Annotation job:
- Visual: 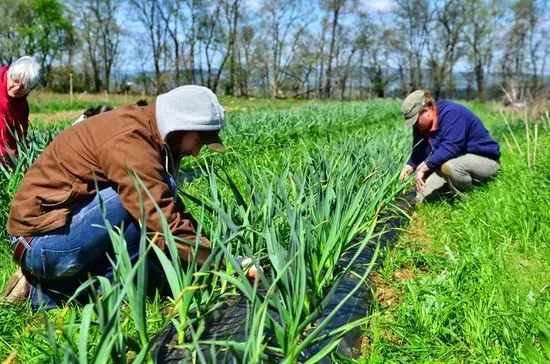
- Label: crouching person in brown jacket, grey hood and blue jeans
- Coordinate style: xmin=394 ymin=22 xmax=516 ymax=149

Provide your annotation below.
xmin=1 ymin=86 xmax=225 ymax=309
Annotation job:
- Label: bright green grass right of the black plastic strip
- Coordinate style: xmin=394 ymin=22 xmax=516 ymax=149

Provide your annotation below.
xmin=364 ymin=106 xmax=550 ymax=363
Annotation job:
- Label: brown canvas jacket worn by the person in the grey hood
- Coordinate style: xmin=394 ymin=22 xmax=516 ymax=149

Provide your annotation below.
xmin=7 ymin=105 xmax=210 ymax=264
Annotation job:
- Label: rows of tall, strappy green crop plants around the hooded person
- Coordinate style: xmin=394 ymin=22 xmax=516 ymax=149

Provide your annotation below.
xmin=0 ymin=102 xmax=409 ymax=363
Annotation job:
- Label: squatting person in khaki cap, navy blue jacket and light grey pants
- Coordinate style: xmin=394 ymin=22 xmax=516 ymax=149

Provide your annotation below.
xmin=400 ymin=90 xmax=500 ymax=203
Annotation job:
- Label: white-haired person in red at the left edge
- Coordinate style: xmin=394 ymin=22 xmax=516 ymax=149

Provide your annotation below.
xmin=0 ymin=56 xmax=40 ymax=164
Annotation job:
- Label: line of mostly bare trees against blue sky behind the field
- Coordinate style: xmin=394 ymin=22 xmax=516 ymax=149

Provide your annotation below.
xmin=0 ymin=0 xmax=550 ymax=100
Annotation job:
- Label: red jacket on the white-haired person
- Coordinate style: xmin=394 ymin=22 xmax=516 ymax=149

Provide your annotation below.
xmin=0 ymin=66 xmax=29 ymax=163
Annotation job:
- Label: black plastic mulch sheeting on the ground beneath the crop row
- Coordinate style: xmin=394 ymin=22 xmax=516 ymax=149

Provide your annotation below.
xmin=154 ymin=193 xmax=414 ymax=363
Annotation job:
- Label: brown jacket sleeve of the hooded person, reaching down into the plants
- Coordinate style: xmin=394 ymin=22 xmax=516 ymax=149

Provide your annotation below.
xmin=98 ymin=129 xmax=210 ymax=265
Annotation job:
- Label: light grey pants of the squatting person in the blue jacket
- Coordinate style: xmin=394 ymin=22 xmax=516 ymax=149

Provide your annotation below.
xmin=416 ymin=154 xmax=500 ymax=203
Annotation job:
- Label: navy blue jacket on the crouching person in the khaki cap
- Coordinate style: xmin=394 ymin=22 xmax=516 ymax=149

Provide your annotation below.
xmin=407 ymin=100 xmax=500 ymax=169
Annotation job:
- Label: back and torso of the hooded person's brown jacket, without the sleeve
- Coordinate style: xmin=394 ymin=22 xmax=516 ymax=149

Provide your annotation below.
xmin=8 ymin=105 xmax=162 ymax=235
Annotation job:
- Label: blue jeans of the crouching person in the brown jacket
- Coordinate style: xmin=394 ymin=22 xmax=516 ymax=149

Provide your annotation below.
xmin=11 ymin=176 xmax=176 ymax=310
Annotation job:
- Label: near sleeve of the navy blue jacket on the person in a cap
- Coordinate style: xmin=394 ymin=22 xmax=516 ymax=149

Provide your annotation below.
xmin=426 ymin=111 xmax=467 ymax=169
